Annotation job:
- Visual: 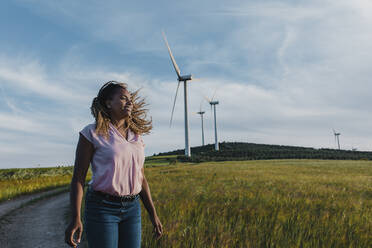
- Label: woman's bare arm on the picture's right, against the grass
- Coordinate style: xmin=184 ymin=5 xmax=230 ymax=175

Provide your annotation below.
xmin=140 ymin=168 xmax=163 ymax=238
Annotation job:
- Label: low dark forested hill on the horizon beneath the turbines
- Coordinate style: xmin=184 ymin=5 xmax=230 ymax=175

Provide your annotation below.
xmin=157 ymin=142 xmax=372 ymax=162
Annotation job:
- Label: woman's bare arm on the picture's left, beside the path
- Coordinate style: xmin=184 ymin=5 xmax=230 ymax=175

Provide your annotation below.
xmin=65 ymin=134 xmax=94 ymax=247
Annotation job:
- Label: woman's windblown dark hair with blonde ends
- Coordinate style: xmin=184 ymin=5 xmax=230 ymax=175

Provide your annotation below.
xmin=90 ymin=81 xmax=152 ymax=139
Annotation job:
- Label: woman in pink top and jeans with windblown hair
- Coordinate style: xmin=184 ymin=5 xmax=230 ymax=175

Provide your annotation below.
xmin=65 ymin=81 xmax=163 ymax=248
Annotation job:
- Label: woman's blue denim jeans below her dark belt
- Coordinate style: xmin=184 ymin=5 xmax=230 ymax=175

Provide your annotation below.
xmin=84 ymin=187 xmax=141 ymax=248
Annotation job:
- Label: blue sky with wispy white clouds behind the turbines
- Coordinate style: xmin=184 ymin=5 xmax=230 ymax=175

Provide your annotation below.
xmin=0 ymin=0 xmax=372 ymax=168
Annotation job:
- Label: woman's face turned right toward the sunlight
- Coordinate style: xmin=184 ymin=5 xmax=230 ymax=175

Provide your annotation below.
xmin=106 ymin=88 xmax=133 ymax=119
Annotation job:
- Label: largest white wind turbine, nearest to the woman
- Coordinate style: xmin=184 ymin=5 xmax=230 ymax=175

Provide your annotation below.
xmin=162 ymin=32 xmax=192 ymax=157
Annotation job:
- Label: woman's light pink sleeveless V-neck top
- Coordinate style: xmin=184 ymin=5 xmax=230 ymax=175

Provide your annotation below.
xmin=80 ymin=123 xmax=145 ymax=196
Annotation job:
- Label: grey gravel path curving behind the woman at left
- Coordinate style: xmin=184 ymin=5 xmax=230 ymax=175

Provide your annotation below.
xmin=0 ymin=192 xmax=69 ymax=248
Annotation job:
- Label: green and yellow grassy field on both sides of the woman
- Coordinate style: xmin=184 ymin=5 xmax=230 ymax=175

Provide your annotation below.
xmin=0 ymin=159 xmax=372 ymax=248
